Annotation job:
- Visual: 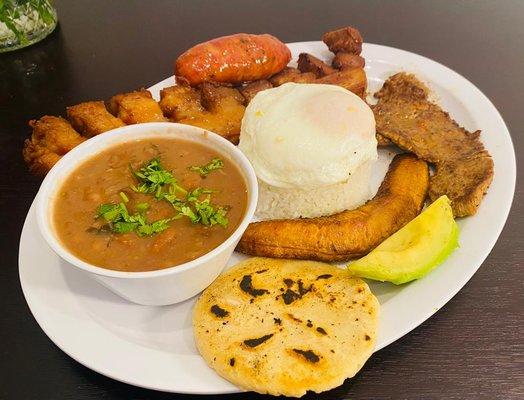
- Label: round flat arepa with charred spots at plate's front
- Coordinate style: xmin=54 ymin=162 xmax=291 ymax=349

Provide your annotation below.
xmin=193 ymin=258 xmax=379 ymax=397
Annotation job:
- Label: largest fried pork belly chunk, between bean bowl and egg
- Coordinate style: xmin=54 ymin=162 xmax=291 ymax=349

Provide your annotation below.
xmin=160 ymin=82 xmax=245 ymax=144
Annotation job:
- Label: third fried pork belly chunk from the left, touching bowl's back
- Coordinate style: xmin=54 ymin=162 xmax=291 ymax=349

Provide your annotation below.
xmin=107 ymin=89 xmax=166 ymax=125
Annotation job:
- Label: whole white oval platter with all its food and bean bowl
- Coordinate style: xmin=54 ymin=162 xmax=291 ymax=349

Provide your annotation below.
xmin=20 ymin=27 xmax=515 ymax=397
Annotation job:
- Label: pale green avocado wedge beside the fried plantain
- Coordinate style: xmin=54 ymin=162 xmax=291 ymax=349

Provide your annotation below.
xmin=348 ymin=196 xmax=459 ymax=285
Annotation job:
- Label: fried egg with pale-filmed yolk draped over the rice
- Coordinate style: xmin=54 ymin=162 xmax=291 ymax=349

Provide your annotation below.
xmin=239 ymin=83 xmax=377 ymax=188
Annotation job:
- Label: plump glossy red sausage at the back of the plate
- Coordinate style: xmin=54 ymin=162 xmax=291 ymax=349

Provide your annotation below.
xmin=175 ymin=33 xmax=291 ymax=86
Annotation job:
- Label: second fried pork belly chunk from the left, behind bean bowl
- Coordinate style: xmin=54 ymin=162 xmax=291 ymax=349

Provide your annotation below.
xmin=67 ymin=101 xmax=125 ymax=138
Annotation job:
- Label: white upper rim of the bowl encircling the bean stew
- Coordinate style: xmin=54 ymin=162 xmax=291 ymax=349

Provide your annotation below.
xmin=36 ymin=122 xmax=258 ymax=279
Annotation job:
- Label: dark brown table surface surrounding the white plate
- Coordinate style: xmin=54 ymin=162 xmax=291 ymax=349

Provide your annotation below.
xmin=0 ymin=0 xmax=524 ymax=400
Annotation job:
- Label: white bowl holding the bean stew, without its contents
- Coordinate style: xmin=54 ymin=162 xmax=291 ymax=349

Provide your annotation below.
xmin=36 ymin=122 xmax=258 ymax=305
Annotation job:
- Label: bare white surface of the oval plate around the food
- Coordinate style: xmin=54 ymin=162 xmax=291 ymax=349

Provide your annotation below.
xmin=19 ymin=42 xmax=516 ymax=394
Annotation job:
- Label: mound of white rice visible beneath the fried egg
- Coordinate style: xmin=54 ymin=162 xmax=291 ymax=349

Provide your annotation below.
xmin=255 ymin=160 xmax=375 ymax=220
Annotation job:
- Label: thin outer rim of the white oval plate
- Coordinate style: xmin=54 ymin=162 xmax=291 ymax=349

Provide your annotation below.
xmin=18 ymin=41 xmax=516 ymax=394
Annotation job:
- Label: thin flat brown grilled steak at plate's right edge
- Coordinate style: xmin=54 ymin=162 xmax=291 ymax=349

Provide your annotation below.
xmin=374 ymin=73 xmax=494 ymax=217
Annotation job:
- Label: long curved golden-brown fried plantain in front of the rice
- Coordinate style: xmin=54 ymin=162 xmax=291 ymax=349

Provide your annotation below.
xmin=237 ymin=154 xmax=429 ymax=262
